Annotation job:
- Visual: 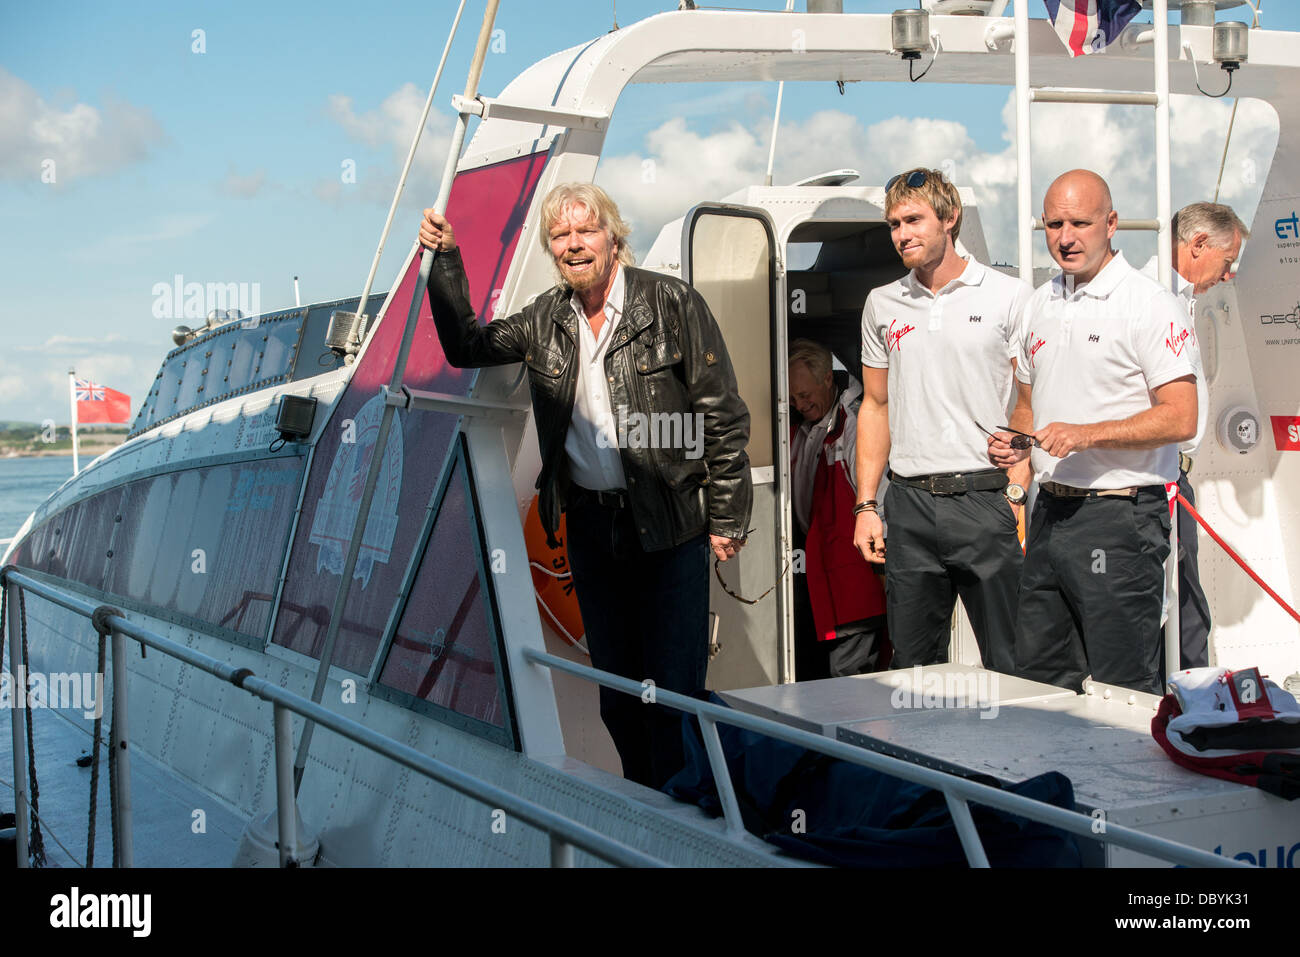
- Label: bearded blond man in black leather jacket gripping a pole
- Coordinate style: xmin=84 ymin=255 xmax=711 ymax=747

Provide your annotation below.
xmin=420 ymin=183 xmax=753 ymax=788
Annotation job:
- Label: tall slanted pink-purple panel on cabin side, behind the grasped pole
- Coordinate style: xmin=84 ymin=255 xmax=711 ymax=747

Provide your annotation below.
xmin=273 ymin=153 xmax=546 ymax=674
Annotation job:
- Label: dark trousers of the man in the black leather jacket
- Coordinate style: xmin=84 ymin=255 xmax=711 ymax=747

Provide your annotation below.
xmin=566 ymin=501 xmax=709 ymax=788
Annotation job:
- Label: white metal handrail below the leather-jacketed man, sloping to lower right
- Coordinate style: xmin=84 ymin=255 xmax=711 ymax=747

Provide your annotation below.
xmin=523 ymin=648 xmax=1249 ymax=867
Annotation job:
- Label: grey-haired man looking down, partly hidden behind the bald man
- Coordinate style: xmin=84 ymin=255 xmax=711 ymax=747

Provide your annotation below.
xmin=1141 ymin=203 xmax=1251 ymax=672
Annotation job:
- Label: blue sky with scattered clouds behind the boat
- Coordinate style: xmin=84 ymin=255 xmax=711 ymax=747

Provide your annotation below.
xmin=0 ymin=0 xmax=1300 ymax=423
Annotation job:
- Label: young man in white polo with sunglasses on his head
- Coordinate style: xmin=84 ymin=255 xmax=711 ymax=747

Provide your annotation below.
xmin=854 ymin=169 xmax=1032 ymax=672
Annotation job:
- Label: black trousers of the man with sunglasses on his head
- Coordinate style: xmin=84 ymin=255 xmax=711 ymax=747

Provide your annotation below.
xmin=884 ymin=482 xmax=1024 ymax=674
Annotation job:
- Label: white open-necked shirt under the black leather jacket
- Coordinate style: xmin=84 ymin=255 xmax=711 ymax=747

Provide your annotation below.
xmin=564 ymin=265 xmax=628 ymax=492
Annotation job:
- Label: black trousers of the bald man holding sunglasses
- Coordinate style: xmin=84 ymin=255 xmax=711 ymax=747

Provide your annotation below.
xmin=1015 ymin=486 xmax=1169 ymax=694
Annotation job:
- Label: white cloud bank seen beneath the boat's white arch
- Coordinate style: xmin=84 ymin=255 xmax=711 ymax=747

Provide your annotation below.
xmin=597 ymin=95 xmax=1277 ymax=265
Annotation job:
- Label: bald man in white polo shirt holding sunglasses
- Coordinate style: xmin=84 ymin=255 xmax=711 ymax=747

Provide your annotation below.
xmin=989 ymin=170 xmax=1196 ymax=694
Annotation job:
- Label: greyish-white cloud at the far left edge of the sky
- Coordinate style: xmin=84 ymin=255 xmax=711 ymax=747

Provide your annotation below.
xmin=0 ymin=68 xmax=164 ymax=185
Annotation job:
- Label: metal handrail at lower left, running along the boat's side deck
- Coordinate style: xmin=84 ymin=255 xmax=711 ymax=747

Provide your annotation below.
xmin=0 ymin=566 xmax=666 ymax=867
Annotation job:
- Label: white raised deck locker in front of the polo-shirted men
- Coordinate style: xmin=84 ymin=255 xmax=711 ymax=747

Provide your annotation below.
xmin=723 ymin=664 xmax=1300 ymax=866
